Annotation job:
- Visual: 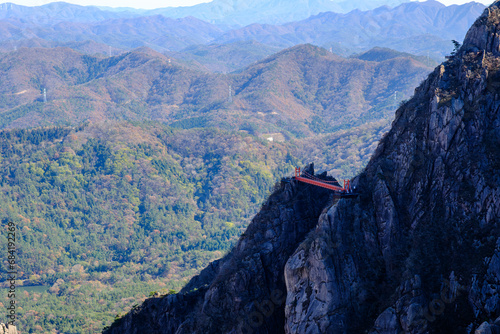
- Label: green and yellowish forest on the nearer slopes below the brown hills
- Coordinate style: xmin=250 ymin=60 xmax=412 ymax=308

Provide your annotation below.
xmin=0 ymin=121 xmax=386 ymax=333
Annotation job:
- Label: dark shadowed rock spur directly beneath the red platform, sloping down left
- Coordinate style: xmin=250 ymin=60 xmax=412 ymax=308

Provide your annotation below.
xmin=104 ymin=166 xmax=332 ymax=334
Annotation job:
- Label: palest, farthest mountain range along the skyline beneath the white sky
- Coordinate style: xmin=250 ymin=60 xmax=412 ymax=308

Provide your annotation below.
xmin=0 ymin=0 xmax=405 ymax=26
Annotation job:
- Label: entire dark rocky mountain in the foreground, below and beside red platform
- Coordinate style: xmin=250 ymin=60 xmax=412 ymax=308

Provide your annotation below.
xmin=105 ymin=2 xmax=500 ymax=334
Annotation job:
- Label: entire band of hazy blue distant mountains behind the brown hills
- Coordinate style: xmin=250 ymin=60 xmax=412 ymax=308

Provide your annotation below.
xmin=0 ymin=0 xmax=484 ymax=58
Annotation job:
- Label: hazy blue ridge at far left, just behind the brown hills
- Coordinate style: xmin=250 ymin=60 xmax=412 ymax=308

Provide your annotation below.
xmin=0 ymin=15 xmax=223 ymax=51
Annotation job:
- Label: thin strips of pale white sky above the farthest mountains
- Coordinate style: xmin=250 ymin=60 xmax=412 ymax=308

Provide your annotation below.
xmin=0 ymin=0 xmax=493 ymax=9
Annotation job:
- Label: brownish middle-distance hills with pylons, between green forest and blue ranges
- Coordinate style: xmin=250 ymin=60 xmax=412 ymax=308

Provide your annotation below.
xmin=0 ymin=45 xmax=431 ymax=139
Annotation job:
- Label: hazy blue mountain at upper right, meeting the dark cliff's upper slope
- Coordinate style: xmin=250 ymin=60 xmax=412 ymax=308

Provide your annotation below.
xmin=217 ymin=1 xmax=484 ymax=58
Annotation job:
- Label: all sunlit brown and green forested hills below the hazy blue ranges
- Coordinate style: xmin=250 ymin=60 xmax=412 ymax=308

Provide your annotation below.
xmin=0 ymin=45 xmax=431 ymax=333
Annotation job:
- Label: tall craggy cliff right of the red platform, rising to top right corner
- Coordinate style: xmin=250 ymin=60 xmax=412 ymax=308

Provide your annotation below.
xmin=285 ymin=2 xmax=500 ymax=334
